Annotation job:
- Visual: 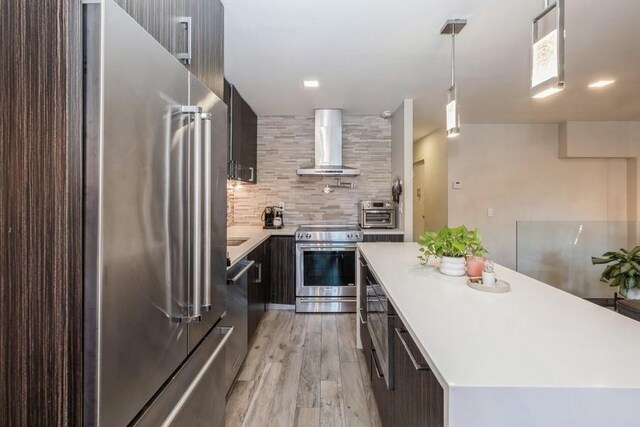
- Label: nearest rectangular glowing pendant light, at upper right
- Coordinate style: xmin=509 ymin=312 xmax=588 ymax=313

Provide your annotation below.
xmin=531 ymin=0 xmax=564 ymax=98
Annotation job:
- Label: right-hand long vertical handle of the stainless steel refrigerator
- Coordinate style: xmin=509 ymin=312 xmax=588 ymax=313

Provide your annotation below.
xmin=201 ymin=113 xmax=213 ymax=312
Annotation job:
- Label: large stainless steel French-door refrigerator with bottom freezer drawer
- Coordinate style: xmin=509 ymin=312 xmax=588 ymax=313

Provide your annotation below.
xmin=84 ymin=0 xmax=233 ymax=427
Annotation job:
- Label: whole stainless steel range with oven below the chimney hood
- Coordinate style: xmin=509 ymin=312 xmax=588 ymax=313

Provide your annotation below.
xmin=296 ymin=225 xmax=363 ymax=313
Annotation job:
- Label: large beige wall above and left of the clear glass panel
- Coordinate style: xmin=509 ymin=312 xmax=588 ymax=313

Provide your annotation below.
xmin=447 ymin=124 xmax=627 ymax=268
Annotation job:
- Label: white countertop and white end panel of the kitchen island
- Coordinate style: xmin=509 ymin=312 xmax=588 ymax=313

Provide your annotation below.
xmin=358 ymin=243 xmax=640 ymax=427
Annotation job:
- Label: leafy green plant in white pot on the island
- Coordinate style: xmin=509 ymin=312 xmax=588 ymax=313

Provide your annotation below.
xmin=418 ymin=225 xmax=487 ymax=276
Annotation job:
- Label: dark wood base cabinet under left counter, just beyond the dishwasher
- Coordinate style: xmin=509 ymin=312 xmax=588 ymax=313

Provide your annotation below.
xmin=247 ymin=240 xmax=271 ymax=342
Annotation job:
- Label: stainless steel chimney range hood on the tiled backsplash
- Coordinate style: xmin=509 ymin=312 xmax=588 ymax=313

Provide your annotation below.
xmin=296 ymin=109 xmax=360 ymax=176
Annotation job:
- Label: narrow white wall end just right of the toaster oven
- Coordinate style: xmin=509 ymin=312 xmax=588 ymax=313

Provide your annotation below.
xmin=391 ymin=99 xmax=413 ymax=242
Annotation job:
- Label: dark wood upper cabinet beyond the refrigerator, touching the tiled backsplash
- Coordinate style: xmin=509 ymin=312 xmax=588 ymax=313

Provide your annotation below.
xmin=226 ymin=85 xmax=258 ymax=183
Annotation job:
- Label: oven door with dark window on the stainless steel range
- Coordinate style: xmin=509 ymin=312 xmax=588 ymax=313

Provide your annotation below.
xmin=296 ymin=243 xmax=357 ymax=301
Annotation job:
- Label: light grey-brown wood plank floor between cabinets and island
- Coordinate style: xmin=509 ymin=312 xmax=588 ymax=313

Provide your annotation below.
xmin=226 ymin=311 xmax=381 ymax=427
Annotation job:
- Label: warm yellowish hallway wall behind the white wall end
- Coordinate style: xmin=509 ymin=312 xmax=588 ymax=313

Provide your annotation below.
xmin=413 ymin=130 xmax=450 ymax=231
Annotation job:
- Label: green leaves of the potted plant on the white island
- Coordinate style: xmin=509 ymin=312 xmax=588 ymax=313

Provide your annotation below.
xmin=418 ymin=225 xmax=487 ymax=264
